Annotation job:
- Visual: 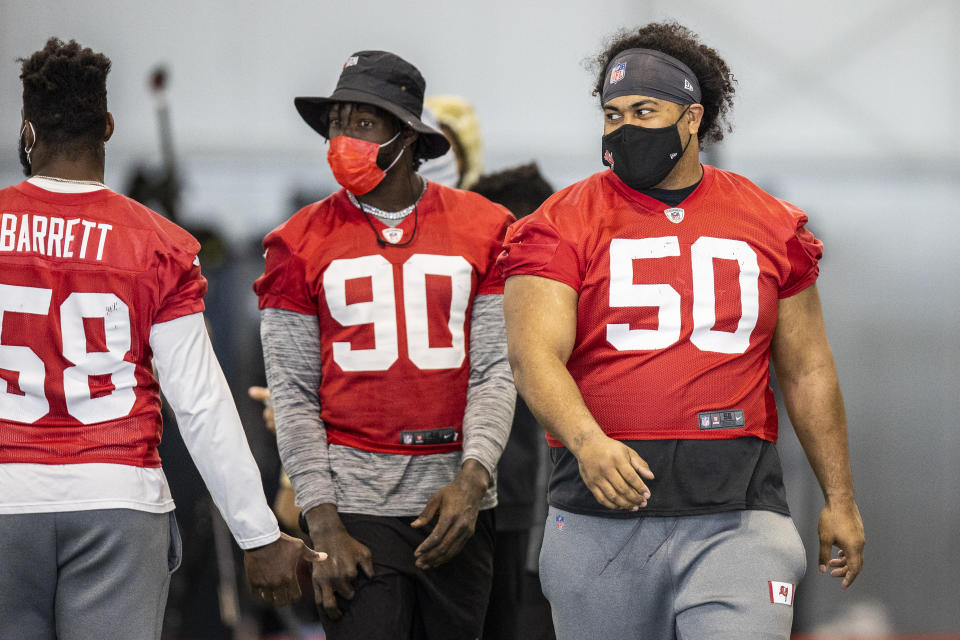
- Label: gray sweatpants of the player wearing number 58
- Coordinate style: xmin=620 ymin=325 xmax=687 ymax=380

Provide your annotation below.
xmin=0 ymin=509 xmax=180 ymax=640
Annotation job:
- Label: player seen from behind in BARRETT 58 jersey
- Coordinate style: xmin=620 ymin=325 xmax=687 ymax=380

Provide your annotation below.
xmin=0 ymin=38 xmax=323 ymax=640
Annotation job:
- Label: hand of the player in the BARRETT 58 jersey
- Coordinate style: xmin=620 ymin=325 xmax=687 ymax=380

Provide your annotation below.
xmin=243 ymin=533 xmax=327 ymax=606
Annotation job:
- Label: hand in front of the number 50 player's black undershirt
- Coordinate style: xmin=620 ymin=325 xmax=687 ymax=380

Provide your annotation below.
xmin=572 ymin=432 xmax=653 ymax=510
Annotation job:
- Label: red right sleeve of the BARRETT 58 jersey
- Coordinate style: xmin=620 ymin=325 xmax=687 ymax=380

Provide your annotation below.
xmin=153 ymin=244 xmax=207 ymax=324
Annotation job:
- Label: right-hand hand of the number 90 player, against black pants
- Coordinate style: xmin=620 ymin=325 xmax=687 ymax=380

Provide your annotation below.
xmin=410 ymin=460 xmax=490 ymax=569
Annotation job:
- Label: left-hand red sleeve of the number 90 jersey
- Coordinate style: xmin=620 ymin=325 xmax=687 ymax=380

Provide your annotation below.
xmin=253 ymin=231 xmax=317 ymax=316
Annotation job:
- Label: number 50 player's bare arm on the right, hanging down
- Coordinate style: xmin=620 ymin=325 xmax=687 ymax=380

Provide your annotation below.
xmin=771 ymin=285 xmax=864 ymax=588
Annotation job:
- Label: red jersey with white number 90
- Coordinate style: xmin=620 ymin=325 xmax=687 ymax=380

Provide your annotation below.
xmin=254 ymin=182 xmax=513 ymax=454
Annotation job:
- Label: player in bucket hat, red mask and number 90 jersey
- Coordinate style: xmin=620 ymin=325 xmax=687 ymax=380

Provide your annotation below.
xmin=254 ymin=51 xmax=516 ymax=640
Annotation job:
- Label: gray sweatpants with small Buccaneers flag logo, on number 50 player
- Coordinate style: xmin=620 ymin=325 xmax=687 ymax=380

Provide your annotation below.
xmin=540 ymin=507 xmax=806 ymax=640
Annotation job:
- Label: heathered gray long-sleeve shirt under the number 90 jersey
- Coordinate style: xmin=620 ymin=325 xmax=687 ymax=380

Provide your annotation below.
xmin=260 ymin=295 xmax=516 ymax=516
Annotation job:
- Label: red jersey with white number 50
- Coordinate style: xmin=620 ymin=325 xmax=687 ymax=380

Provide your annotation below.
xmin=499 ymin=166 xmax=822 ymax=446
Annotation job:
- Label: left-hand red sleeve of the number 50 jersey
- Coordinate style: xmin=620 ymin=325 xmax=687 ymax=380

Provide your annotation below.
xmin=497 ymin=214 xmax=583 ymax=291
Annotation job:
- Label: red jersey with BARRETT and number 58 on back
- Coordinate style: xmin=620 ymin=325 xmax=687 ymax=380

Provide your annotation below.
xmin=0 ymin=182 xmax=207 ymax=467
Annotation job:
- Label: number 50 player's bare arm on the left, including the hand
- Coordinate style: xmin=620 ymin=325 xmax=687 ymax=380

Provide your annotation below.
xmin=504 ymin=276 xmax=653 ymax=510
